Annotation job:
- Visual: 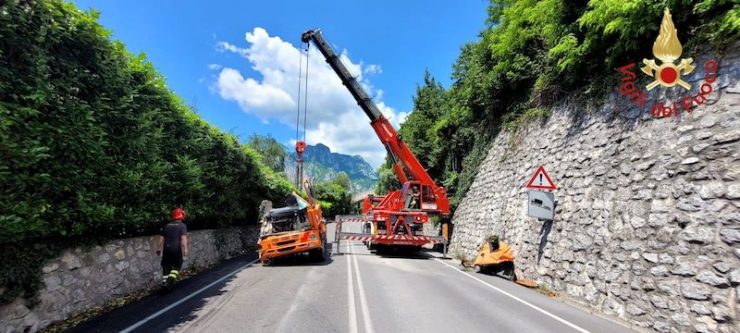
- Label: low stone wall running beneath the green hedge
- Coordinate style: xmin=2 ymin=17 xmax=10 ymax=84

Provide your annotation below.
xmin=0 ymin=225 xmax=259 ymax=332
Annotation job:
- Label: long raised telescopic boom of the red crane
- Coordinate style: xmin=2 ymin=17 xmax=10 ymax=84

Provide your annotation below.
xmin=301 ymin=29 xmax=450 ymax=216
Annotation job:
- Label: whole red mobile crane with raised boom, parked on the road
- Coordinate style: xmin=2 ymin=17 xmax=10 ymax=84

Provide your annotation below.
xmin=301 ymin=29 xmax=450 ymax=247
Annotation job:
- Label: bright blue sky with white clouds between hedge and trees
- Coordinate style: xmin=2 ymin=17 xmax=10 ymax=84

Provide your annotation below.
xmin=75 ymin=0 xmax=487 ymax=166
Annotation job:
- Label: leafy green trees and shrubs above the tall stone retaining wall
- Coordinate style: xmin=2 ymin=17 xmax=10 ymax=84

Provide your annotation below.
xmin=376 ymin=0 xmax=740 ymax=208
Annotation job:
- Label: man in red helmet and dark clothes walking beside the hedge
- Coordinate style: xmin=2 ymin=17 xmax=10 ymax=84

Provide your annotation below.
xmin=157 ymin=207 xmax=189 ymax=284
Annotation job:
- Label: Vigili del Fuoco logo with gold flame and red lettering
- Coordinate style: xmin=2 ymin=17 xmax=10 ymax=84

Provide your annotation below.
xmin=619 ymin=8 xmax=719 ymax=118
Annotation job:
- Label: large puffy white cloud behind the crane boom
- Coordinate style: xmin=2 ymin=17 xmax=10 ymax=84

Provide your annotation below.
xmin=214 ymin=27 xmax=407 ymax=167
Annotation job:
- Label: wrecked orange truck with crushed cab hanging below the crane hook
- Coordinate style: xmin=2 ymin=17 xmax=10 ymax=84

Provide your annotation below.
xmin=257 ymin=186 xmax=326 ymax=265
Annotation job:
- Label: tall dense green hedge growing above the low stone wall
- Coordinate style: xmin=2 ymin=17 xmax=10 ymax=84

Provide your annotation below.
xmin=0 ymin=0 xmax=291 ymax=301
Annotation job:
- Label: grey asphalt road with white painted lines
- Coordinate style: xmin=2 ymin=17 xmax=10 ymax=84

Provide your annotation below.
xmin=70 ymin=220 xmax=631 ymax=333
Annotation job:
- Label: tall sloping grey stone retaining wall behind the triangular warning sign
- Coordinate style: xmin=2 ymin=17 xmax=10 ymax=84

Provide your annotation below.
xmin=450 ymin=45 xmax=740 ymax=332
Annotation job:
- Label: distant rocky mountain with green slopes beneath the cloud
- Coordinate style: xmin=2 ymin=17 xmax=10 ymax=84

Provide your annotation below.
xmin=285 ymin=143 xmax=378 ymax=192
